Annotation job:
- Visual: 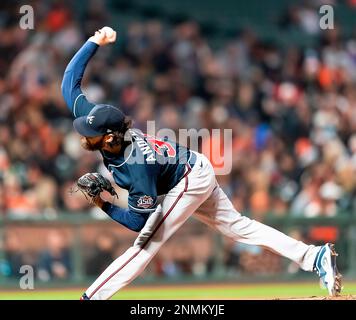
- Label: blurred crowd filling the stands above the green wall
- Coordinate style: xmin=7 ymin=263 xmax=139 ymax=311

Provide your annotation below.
xmin=0 ymin=1 xmax=356 ymax=278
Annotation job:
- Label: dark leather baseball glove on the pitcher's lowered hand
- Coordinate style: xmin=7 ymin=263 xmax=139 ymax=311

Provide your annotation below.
xmin=77 ymin=172 xmax=118 ymax=202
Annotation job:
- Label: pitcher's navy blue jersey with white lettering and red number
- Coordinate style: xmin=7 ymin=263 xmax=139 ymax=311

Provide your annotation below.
xmin=101 ymin=129 xmax=192 ymax=212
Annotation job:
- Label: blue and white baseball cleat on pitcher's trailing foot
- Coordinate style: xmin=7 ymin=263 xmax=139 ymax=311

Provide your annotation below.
xmin=314 ymin=243 xmax=342 ymax=296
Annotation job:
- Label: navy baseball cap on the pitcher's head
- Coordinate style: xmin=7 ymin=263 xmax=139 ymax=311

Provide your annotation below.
xmin=73 ymin=104 xmax=125 ymax=137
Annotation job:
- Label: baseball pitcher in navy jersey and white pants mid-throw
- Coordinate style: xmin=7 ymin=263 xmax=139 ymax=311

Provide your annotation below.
xmin=62 ymin=27 xmax=341 ymax=300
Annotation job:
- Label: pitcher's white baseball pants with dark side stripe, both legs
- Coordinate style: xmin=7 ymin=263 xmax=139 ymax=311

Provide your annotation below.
xmin=86 ymin=153 xmax=320 ymax=300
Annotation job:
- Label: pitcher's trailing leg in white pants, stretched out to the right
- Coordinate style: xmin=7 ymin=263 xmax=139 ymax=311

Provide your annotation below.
xmin=196 ymin=187 xmax=320 ymax=271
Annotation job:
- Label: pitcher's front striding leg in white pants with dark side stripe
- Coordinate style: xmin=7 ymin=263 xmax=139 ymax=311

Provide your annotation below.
xmin=86 ymin=160 xmax=214 ymax=300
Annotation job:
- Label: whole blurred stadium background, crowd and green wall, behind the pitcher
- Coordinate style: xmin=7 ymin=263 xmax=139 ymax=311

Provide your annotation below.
xmin=0 ymin=0 xmax=356 ymax=297
